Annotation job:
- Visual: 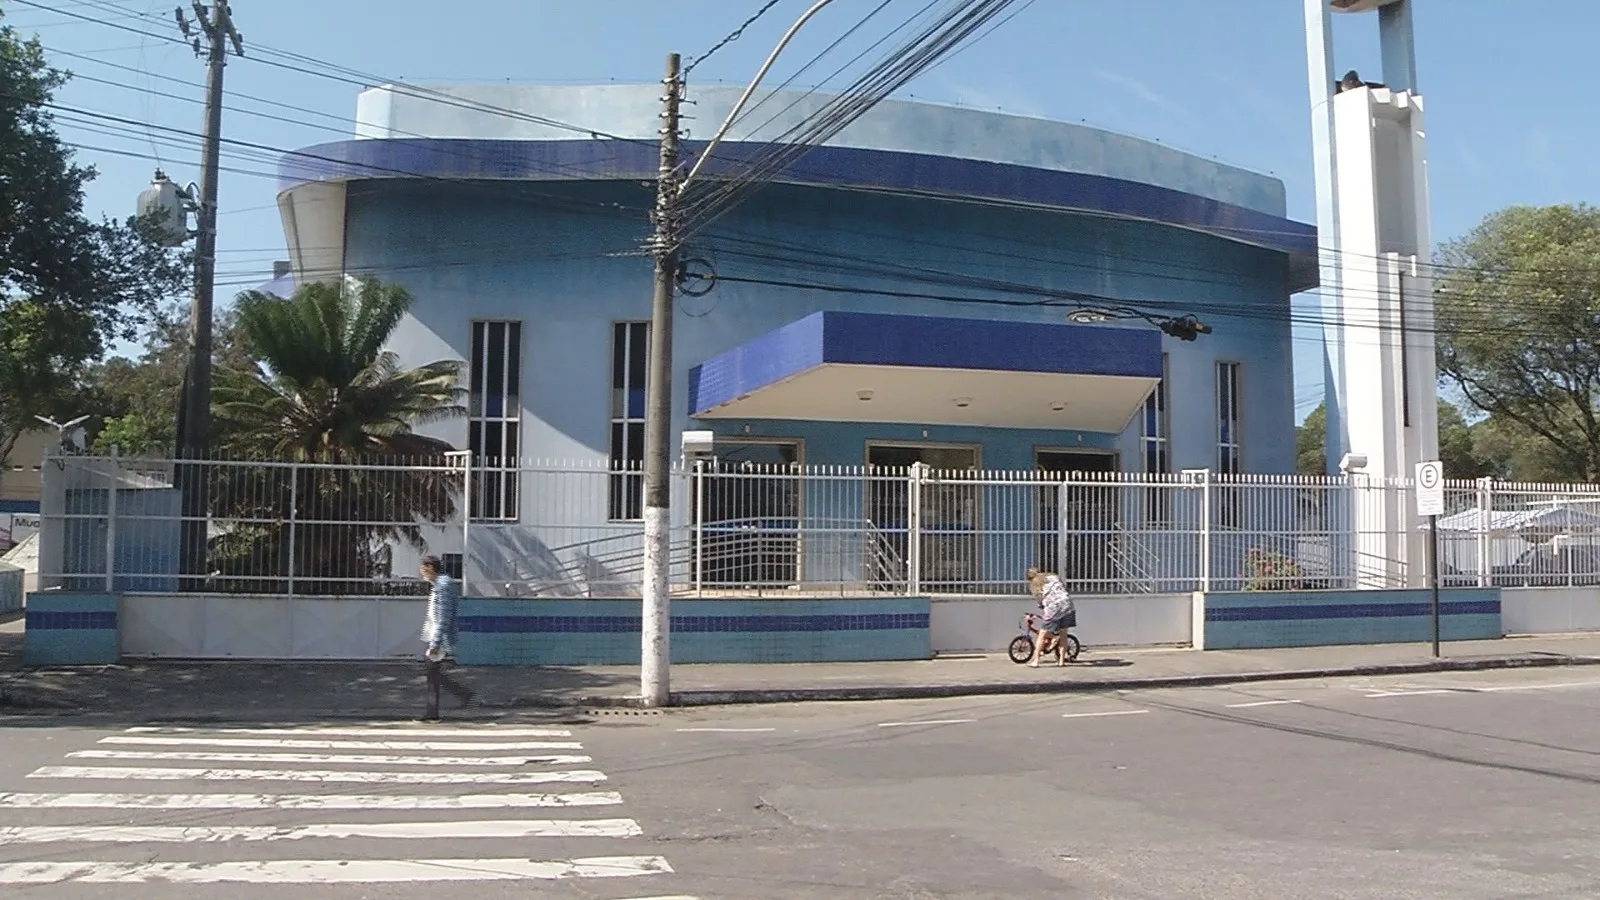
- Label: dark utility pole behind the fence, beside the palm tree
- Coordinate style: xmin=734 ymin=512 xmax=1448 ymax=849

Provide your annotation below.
xmin=176 ymin=0 xmax=245 ymax=586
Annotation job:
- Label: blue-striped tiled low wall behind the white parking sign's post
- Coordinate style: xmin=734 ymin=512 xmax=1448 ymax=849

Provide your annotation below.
xmin=1194 ymin=588 xmax=1504 ymax=650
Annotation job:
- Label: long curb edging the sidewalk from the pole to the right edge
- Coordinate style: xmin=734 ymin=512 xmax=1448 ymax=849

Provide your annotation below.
xmin=537 ymin=655 xmax=1600 ymax=709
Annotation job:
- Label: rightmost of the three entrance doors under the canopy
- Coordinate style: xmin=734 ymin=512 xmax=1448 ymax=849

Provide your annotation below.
xmin=1034 ymin=450 xmax=1122 ymax=594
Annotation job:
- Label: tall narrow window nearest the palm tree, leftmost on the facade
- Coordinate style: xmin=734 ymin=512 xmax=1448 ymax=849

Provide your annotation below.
xmin=467 ymin=322 xmax=522 ymax=520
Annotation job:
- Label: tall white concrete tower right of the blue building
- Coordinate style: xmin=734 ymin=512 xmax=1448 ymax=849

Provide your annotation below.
xmin=1304 ymin=0 xmax=1448 ymax=588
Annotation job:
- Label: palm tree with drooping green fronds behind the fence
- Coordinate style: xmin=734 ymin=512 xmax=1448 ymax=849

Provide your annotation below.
xmin=211 ymin=279 xmax=466 ymax=594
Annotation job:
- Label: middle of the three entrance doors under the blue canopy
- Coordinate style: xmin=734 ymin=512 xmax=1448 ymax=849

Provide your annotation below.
xmin=867 ymin=444 xmax=979 ymax=594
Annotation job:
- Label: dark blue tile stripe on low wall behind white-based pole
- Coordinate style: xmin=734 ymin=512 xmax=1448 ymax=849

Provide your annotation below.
xmin=458 ymin=613 xmax=928 ymax=634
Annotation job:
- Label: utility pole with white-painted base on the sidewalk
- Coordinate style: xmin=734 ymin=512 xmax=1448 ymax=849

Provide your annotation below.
xmin=638 ymin=53 xmax=683 ymax=706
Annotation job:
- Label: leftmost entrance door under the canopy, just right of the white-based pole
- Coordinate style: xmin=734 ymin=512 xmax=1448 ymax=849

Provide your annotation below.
xmin=694 ymin=440 xmax=800 ymax=588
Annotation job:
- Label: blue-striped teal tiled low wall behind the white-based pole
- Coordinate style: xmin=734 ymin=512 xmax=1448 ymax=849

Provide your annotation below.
xmin=456 ymin=597 xmax=933 ymax=666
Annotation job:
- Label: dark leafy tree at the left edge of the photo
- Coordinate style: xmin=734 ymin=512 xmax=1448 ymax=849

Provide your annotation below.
xmin=0 ymin=17 xmax=189 ymax=474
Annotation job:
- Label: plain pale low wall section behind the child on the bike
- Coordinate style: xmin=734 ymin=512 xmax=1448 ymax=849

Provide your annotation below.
xmin=930 ymin=594 xmax=1194 ymax=653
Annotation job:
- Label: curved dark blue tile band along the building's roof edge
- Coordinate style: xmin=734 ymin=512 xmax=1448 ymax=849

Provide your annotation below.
xmin=278 ymin=138 xmax=1317 ymax=275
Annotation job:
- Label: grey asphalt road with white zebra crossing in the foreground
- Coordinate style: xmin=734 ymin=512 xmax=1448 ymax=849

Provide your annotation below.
xmin=0 ymin=668 xmax=1600 ymax=900
